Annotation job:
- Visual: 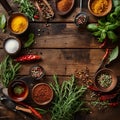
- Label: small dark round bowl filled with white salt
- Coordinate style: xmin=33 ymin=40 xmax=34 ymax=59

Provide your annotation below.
xmin=3 ymin=37 xmax=21 ymax=55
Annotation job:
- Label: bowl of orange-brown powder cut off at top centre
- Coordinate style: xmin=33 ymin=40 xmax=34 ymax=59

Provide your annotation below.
xmin=56 ymin=0 xmax=75 ymax=15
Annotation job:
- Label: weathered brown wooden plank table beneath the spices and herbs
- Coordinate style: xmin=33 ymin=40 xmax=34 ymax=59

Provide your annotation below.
xmin=0 ymin=0 xmax=120 ymax=120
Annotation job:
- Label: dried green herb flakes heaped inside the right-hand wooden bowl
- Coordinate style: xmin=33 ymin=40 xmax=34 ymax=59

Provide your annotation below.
xmin=97 ymin=74 xmax=112 ymax=88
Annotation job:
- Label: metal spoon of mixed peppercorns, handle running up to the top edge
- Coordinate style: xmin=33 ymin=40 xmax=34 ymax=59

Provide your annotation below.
xmin=74 ymin=0 xmax=88 ymax=27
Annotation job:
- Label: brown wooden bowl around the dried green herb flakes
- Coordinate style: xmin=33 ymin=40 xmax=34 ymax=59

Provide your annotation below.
xmin=94 ymin=68 xmax=117 ymax=92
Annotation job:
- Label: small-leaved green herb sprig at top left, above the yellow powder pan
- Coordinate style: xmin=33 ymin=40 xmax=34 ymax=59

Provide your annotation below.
xmin=14 ymin=0 xmax=35 ymax=21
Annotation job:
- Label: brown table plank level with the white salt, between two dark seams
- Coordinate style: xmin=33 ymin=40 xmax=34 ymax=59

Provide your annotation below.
xmin=0 ymin=23 xmax=99 ymax=48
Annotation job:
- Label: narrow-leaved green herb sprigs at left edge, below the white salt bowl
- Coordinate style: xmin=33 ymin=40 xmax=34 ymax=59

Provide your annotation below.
xmin=0 ymin=56 xmax=21 ymax=87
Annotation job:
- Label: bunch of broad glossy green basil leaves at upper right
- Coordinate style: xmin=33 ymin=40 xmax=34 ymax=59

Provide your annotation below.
xmin=87 ymin=5 xmax=120 ymax=42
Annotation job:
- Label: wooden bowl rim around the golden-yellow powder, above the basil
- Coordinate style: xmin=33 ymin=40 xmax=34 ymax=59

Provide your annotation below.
xmin=88 ymin=0 xmax=112 ymax=17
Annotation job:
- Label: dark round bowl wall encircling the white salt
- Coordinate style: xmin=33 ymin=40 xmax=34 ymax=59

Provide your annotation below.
xmin=3 ymin=36 xmax=22 ymax=56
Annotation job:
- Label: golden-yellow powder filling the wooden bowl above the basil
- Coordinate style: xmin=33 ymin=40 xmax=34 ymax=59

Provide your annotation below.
xmin=91 ymin=0 xmax=109 ymax=14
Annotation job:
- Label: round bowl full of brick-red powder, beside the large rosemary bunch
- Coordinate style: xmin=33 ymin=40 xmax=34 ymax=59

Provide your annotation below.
xmin=32 ymin=83 xmax=53 ymax=105
